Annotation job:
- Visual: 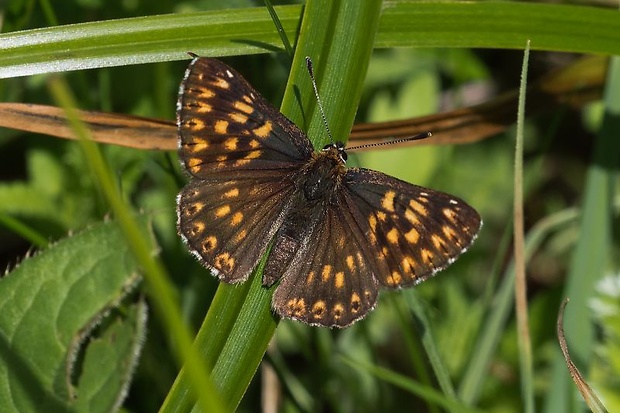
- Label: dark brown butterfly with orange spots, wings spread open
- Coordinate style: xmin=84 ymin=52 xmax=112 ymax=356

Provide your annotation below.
xmin=176 ymin=56 xmax=482 ymax=327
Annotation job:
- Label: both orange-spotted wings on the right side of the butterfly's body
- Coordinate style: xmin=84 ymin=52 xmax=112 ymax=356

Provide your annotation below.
xmin=272 ymin=168 xmax=481 ymax=327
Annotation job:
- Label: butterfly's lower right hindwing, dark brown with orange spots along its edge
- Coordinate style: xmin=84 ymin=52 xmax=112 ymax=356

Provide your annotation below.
xmin=272 ymin=205 xmax=378 ymax=327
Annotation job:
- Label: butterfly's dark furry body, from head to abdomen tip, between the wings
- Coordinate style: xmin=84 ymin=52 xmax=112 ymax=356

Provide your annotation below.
xmin=263 ymin=143 xmax=346 ymax=285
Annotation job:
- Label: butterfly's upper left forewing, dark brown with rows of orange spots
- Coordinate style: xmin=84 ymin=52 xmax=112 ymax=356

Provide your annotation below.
xmin=177 ymin=58 xmax=312 ymax=178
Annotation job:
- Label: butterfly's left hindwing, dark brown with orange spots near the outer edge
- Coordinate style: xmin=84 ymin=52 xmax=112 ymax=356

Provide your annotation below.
xmin=177 ymin=171 xmax=300 ymax=283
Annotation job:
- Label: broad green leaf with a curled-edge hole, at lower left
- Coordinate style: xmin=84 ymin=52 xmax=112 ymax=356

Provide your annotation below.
xmin=0 ymin=220 xmax=147 ymax=412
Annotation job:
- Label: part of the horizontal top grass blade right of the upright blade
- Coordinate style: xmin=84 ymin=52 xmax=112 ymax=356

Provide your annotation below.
xmin=376 ymin=1 xmax=620 ymax=54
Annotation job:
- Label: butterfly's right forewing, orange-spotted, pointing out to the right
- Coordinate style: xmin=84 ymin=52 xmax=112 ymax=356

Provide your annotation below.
xmin=341 ymin=168 xmax=482 ymax=288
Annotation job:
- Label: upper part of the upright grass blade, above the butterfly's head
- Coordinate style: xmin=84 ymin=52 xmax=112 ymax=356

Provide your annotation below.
xmin=282 ymin=0 xmax=381 ymax=148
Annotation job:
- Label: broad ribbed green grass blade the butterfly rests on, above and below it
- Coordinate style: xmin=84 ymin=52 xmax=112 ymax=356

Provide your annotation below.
xmin=207 ymin=0 xmax=381 ymax=408
